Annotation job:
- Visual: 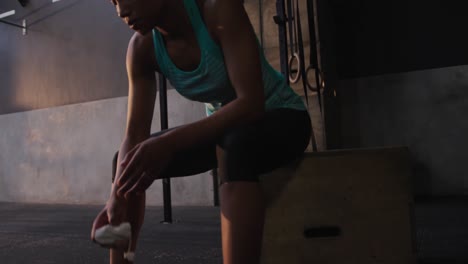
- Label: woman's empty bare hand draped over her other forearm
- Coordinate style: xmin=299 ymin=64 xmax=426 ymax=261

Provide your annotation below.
xmin=116 ymin=137 xmax=174 ymax=198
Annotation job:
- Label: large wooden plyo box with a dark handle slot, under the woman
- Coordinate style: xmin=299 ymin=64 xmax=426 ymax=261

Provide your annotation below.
xmin=260 ymin=147 xmax=416 ymax=264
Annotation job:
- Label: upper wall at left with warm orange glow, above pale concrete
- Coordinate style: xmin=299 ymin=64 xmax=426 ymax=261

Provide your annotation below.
xmin=0 ymin=0 xmax=132 ymax=114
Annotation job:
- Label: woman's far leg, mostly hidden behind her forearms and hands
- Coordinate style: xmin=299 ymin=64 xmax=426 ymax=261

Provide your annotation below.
xmin=106 ymin=127 xmax=217 ymax=264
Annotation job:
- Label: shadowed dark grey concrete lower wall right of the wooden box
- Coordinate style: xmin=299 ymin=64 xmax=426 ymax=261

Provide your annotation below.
xmin=337 ymin=66 xmax=468 ymax=195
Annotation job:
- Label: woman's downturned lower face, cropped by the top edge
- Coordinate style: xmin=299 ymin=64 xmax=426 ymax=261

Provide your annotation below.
xmin=111 ymin=0 xmax=163 ymax=35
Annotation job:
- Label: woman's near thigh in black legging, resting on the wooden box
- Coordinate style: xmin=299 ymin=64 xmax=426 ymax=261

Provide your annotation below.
xmin=218 ymin=108 xmax=311 ymax=182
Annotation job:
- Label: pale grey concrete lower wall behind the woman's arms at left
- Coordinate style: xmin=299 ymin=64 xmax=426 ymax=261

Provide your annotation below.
xmin=0 ymin=90 xmax=213 ymax=205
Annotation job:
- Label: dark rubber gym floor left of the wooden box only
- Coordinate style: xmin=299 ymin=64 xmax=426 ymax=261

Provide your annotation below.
xmin=0 ymin=203 xmax=222 ymax=264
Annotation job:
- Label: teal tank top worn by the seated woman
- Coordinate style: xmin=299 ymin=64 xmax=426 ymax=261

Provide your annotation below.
xmin=153 ymin=0 xmax=306 ymax=116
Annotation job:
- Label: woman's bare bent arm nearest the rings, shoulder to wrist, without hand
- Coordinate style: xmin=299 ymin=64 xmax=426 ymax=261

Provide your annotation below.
xmin=165 ymin=0 xmax=265 ymax=150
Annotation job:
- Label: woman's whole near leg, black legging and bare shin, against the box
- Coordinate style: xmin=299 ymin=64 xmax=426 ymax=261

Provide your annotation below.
xmin=217 ymin=109 xmax=311 ymax=264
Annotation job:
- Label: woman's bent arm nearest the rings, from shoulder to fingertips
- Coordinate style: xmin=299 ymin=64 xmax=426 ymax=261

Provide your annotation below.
xmin=119 ymin=0 xmax=265 ymax=193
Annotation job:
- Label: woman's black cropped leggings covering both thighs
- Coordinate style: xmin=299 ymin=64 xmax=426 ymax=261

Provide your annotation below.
xmin=151 ymin=108 xmax=311 ymax=182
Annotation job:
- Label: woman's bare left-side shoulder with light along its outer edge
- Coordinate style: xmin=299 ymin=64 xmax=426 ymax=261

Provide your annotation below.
xmin=127 ymin=32 xmax=159 ymax=76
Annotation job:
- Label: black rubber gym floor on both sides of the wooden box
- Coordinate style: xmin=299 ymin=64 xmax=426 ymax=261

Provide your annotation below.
xmin=0 ymin=199 xmax=468 ymax=264
